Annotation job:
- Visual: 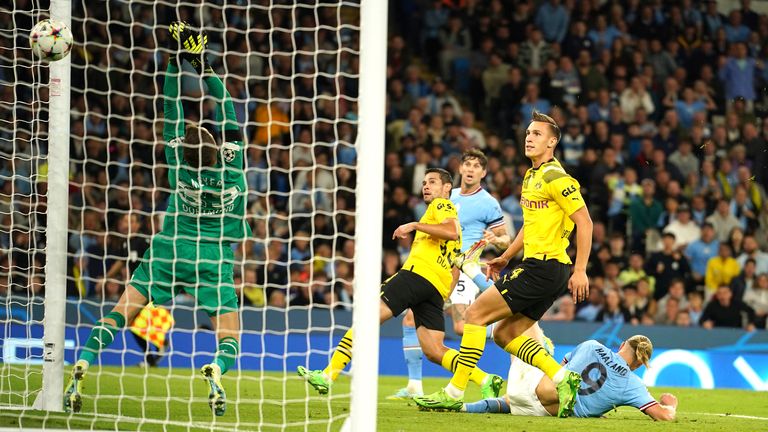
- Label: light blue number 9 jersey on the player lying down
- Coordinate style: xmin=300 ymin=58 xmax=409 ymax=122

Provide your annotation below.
xmin=565 ymin=340 xmax=658 ymax=417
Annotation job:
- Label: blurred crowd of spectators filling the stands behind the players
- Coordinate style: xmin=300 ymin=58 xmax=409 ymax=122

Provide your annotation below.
xmin=0 ymin=0 xmax=768 ymax=329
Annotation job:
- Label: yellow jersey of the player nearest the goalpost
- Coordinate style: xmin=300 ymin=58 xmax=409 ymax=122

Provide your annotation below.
xmin=403 ymin=198 xmax=461 ymax=299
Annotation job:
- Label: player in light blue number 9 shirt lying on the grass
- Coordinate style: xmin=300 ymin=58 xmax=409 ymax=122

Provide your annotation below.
xmin=459 ymin=335 xmax=677 ymax=420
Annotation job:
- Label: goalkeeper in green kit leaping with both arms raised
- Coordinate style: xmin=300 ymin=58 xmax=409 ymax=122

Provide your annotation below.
xmin=64 ymin=22 xmax=251 ymax=416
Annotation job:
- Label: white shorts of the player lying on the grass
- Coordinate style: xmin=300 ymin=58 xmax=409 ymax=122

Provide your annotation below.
xmin=506 ymin=357 xmax=550 ymax=417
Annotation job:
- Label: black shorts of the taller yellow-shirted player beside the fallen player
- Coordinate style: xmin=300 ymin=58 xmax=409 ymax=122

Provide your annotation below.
xmin=496 ymin=258 xmax=571 ymax=321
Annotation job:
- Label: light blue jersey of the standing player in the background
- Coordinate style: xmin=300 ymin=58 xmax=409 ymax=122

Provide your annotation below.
xmin=451 ymin=188 xmax=504 ymax=252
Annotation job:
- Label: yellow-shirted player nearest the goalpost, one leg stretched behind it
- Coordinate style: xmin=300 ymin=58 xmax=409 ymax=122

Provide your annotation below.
xmin=297 ymin=168 xmax=503 ymax=397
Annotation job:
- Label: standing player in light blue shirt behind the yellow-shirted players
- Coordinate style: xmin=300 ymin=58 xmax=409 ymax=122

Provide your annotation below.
xmin=388 ymin=149 xmax=510 ymax=400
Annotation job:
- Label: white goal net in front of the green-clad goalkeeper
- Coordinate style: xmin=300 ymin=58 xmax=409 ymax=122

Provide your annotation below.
xmin=0 ymin=0 xmax=383 ymax=430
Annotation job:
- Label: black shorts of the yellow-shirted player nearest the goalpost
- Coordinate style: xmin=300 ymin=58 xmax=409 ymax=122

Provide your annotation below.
xmin=381 ymin=269 xmax=445 ymax=332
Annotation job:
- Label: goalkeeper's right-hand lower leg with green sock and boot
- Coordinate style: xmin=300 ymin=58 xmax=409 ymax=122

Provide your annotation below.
xmin=200 ymin=312 xmax=240 ymax=416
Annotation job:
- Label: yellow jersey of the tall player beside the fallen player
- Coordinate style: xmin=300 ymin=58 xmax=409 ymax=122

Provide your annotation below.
xmin=520 ymin=159 xmax=586 ymax=264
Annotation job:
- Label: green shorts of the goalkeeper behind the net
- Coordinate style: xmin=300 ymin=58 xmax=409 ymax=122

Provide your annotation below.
xmin=130 ymin=236 xmax=237 ymax=316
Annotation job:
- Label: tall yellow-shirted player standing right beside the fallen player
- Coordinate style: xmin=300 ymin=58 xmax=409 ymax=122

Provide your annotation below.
xmin=413 ymin=111 xmax=592 ymax=417
